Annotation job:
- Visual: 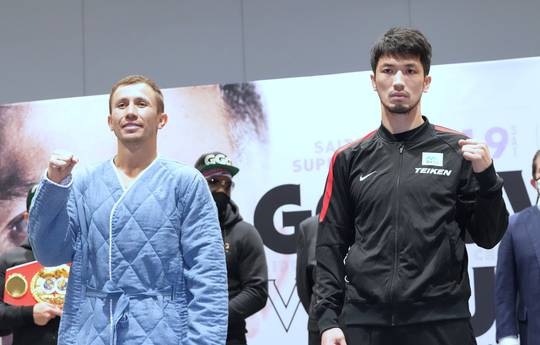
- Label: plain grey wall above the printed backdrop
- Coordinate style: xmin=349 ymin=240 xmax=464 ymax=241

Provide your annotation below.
xmin=0 ymin=0 xmax=540 ymax=103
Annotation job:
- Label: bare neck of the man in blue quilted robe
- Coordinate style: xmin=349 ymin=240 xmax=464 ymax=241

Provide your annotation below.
xmin=114 ymin=142 xmax=157 ymax=178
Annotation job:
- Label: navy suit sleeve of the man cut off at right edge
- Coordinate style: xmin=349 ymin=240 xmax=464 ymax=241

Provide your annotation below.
xmin=495 ymin=218 xmax=518 ymax=340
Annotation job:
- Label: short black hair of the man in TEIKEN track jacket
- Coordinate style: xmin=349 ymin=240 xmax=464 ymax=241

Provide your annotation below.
xmin=370 ymin=27 xmax=431 ymax=75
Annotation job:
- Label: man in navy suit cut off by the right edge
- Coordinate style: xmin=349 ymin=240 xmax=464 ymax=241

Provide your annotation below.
xmin=495 ymin=150 xmax=540 ymax=345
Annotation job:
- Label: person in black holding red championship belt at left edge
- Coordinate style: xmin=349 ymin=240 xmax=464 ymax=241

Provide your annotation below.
xmin=0 ymin=186 xmax=62 ymax=345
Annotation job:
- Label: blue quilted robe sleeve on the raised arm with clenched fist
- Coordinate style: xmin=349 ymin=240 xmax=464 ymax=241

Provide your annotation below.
xmin=28 ymin=176 xmax=80 ymax=266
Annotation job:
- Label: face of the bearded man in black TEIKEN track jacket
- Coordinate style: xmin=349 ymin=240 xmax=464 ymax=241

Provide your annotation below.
xmin=371 ymin=55 xmax=431 ymax=114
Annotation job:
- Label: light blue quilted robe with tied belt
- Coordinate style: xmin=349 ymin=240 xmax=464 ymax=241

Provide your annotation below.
xmin=29 ymin=158 xmax=228 ymax=345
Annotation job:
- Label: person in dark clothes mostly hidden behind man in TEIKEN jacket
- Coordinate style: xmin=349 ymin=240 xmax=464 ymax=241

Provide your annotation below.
xmin=296 ymin=215 xmax=321 ymax=345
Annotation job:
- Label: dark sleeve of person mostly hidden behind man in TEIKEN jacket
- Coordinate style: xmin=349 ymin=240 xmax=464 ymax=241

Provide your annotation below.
xmin=296 ymin=220 xmax=312 ymax=313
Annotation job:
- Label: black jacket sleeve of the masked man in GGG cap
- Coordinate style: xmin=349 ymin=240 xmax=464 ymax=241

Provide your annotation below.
xmin=229 ymin=227 xmax=268 ymax=319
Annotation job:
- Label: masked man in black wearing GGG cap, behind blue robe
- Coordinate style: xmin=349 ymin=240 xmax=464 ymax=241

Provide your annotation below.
xmin=195 ymin=152 xmax=268 ymax=345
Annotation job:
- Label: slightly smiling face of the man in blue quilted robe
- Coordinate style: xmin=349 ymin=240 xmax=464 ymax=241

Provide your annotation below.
xmin=108 ymin=83 xmax=167 ymax=143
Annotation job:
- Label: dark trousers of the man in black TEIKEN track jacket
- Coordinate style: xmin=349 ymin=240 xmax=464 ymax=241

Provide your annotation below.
xmin=344 ymin=319 xmax=476 ymax=345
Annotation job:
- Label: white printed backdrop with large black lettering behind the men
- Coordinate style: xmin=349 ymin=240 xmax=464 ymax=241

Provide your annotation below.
xmin=0 ymin=58 xmax=540 ymax=345
